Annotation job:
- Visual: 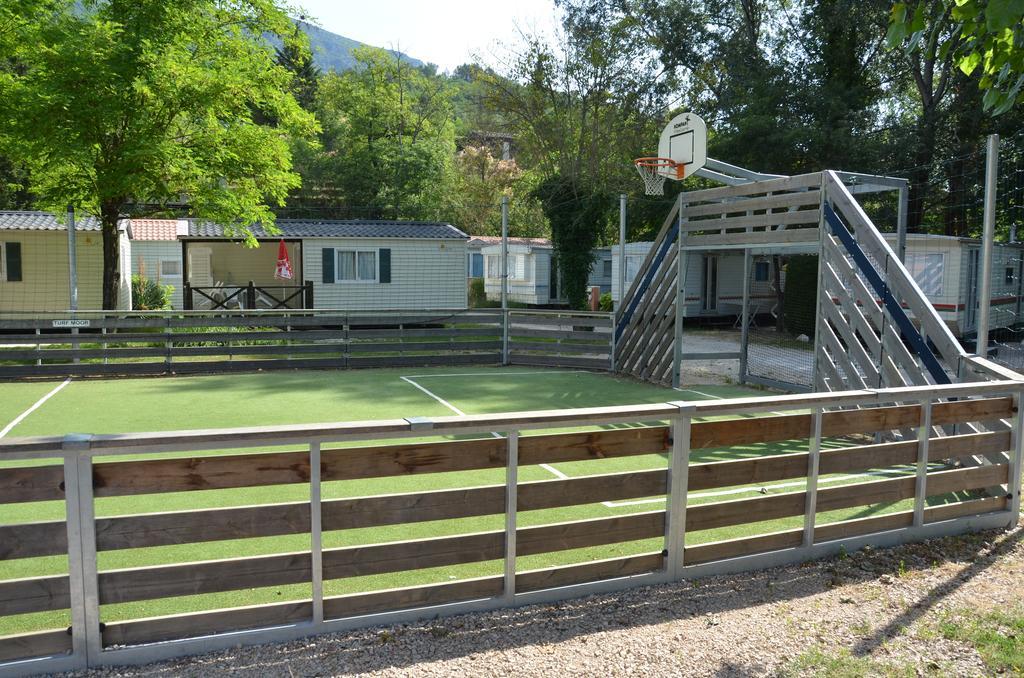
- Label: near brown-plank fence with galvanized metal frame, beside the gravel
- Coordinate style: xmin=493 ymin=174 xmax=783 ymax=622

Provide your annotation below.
xmin=0 ymin=381 xmax=1024 ymax=673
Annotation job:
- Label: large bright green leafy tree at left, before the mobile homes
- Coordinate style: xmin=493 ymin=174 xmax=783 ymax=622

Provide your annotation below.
xmin=0 ymin=0 xmax=315 ymax=308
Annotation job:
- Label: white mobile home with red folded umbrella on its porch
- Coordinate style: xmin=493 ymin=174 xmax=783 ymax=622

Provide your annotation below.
xmin=180 ymin=219 xmax=469 ymax=310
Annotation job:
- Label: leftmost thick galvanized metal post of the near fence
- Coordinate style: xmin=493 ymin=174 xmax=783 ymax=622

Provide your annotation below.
xmin=60 ymin=433 xmax=102 ymax=666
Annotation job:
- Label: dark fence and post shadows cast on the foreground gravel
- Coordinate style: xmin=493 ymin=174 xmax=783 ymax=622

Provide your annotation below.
xmin=117 ymin=531 xmax=1024 ymax=676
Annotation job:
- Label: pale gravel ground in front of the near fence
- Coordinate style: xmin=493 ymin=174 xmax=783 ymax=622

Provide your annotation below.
xmin=66 ymin=522 xmax=1024 ymax=677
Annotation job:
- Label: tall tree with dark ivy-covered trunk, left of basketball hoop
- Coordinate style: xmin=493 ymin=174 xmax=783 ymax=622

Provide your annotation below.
xmin=480 ymin=0 xmax=670 ymax=307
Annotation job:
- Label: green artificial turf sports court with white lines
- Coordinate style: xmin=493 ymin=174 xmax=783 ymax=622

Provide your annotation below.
xmin=0 ymin=368 xmax=958 ymax=635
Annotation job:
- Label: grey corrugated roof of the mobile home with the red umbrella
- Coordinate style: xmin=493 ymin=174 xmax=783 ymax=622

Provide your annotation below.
xmin=183 ymin=219 xmax=469 ymax=240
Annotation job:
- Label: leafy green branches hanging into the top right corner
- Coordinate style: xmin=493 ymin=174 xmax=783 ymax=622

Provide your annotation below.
xmin=888 ymin=0 xmax=1024 ymax=115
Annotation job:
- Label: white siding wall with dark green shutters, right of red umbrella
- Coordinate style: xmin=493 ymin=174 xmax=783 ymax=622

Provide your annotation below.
xmin=302 ymin=238 xmax=467 ymax=310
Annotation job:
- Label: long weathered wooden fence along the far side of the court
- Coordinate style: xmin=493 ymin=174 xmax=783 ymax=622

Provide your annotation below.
xmin=0 ymin=309 xmax=611 ymax=378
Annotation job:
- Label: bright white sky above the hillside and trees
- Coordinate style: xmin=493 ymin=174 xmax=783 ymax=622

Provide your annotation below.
xmin=297 ymin=0 xmax=556 ymax=71
